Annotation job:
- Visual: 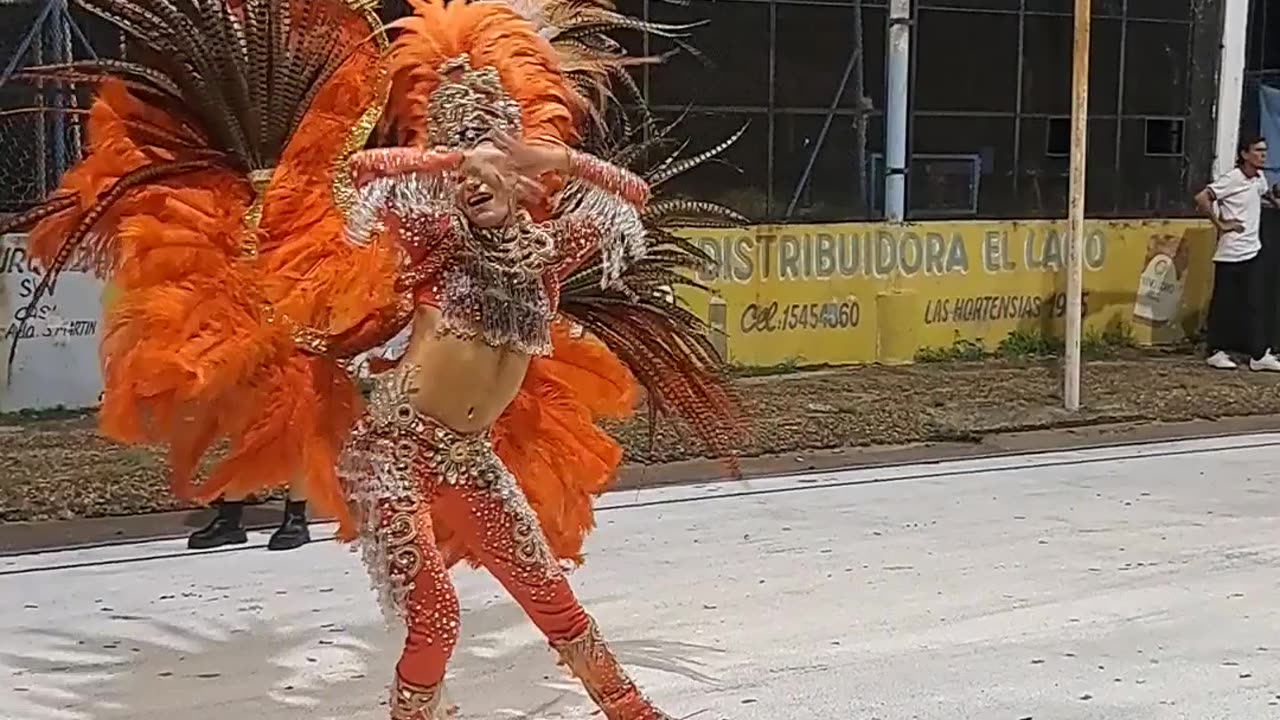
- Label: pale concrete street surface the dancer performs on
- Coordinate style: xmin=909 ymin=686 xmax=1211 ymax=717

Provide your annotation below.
xmin=0 ymin=434 xmax=1280 ymax=720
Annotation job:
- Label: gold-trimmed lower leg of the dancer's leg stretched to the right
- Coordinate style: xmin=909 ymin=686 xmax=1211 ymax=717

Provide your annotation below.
xmin=552 ymin=609 xmax=671 ymax=720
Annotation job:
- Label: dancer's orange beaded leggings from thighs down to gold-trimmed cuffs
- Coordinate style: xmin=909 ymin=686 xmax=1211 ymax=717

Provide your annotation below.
xmin=381 ymin=475 xmax=590 ymax=687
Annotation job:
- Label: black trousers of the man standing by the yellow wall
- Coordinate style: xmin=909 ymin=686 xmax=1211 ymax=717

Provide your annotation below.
xmin=1208 ymin=258 xmax=1268 ymax=360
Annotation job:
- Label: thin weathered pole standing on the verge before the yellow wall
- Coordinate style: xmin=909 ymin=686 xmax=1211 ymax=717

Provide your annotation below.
xmin=1062 ymin=0 xmax=1091 ymax=411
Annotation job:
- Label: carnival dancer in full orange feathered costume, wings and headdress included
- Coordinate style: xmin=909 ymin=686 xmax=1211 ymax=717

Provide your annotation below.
xmin=5 ymin=0 xmax=740 ymax=720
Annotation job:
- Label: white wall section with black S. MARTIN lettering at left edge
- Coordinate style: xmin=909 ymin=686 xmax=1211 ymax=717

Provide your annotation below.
xmin=0 ymin=234 xmax=102 ymax=413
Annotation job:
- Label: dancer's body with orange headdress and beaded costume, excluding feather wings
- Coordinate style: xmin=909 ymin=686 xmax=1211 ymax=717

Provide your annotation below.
xmin=308 ymin=0 xmax=733 ymax=720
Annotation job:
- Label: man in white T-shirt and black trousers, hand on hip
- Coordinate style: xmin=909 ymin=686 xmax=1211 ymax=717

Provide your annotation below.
xmin=1196 ymin=136 xmax=1280 ymax=372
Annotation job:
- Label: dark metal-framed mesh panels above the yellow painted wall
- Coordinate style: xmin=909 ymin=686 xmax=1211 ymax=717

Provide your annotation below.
xmin=621 ymin=0 xmax=1218 ymax=222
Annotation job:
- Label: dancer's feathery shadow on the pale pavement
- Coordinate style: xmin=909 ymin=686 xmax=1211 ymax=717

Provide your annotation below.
xmin=0 ymin=589 xmax=722 ymax=720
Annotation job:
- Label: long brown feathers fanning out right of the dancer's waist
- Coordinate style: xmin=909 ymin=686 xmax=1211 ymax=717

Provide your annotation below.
xmin=559 ymin=113 xmax=748 ymax=473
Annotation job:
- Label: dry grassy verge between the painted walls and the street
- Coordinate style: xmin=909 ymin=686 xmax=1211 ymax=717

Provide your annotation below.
xmin=0 ymin=356 xmax=1280 ymax=523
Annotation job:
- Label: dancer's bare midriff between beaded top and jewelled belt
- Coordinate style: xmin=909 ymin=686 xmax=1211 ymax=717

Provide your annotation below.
xmin=393 ymin=305 xmax=530 ymax=433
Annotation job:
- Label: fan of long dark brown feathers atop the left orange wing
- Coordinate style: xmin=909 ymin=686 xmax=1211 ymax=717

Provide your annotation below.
xmin=0 ymin=0 xmax=384 ymax=365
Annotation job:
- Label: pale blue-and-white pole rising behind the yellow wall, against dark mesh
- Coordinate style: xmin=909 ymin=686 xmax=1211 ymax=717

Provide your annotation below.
xmin=884 ymin=0 xmax=911 ymax=223
